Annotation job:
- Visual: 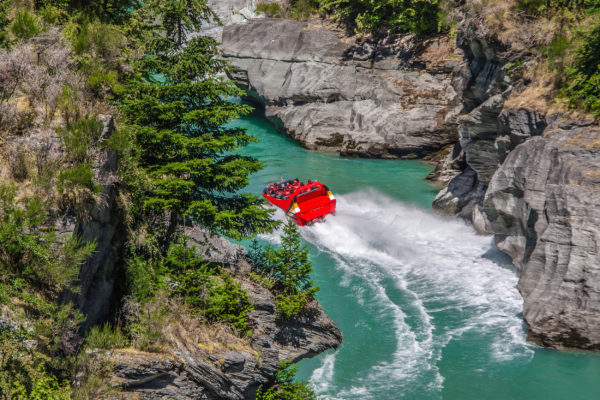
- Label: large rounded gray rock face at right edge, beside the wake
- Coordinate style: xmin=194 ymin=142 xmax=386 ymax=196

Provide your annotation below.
xmin=482 ymin=126 xmax=600 ymax=350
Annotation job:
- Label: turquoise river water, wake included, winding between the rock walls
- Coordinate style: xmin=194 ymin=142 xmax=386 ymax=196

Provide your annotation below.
xmin=231 ymin=112 xmax=600 ymax=400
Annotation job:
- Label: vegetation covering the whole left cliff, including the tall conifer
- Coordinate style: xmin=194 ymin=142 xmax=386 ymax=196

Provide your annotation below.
xmin=0 ymin=0 xmax=322 ymax=399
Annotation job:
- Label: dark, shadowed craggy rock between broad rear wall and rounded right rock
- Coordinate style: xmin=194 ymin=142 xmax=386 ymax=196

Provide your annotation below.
xmin=433 ymin=32 xmax=514 ymax=221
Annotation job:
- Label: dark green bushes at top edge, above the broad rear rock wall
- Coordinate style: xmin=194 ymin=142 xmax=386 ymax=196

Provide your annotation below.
xmin=321 ymin=0 xmax=440 ymax=33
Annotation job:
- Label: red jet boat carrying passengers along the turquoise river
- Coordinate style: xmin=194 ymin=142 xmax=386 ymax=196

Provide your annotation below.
xmin=263 ymin=179 xmax=336 ymax=226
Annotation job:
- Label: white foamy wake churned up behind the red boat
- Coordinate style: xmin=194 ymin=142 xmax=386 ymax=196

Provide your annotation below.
xmin=302 ymin=191 xmax=532 ymax=399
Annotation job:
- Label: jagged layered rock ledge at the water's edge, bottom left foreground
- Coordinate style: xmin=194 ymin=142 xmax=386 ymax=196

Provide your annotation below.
xmin=105 ymin=236 xmax=342 ymax=400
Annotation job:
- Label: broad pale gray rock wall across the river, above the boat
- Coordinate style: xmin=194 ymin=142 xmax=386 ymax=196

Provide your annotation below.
xmin=221 ymin=19 xmax=463 ymax=158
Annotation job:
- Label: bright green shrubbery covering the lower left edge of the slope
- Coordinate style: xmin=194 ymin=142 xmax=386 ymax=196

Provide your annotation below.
xmin=0 ymin=185 xmax=95 ymax=398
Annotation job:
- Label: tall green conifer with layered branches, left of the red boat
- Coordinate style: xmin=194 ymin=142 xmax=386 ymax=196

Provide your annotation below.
xmin=121 ymin=0 xmax=276 ymax=239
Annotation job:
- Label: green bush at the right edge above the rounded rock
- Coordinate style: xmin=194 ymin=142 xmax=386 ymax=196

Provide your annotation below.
xmin=563 ymin=23 xmax=600 ymax=117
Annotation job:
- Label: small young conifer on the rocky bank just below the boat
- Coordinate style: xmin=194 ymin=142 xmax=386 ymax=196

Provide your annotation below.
xmin=248 ymin=221 xmax=319 ymax=320
